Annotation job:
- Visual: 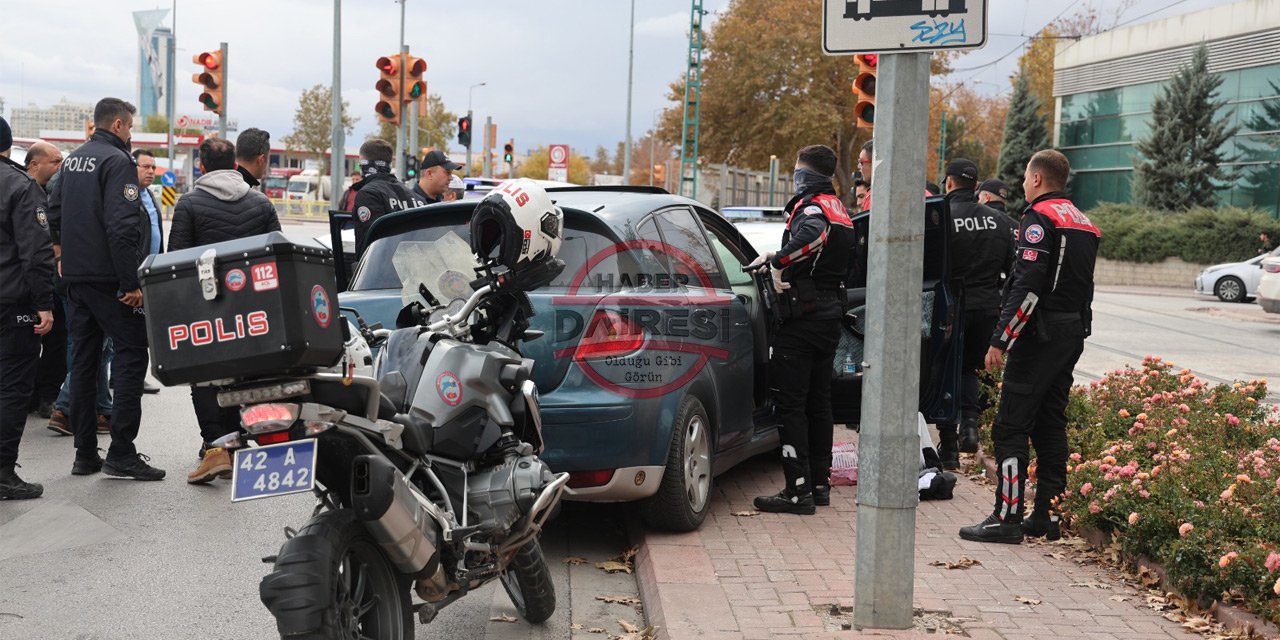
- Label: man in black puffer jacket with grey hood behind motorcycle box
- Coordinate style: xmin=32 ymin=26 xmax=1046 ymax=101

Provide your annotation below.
xmin=169 ymin=138 xmax=280 ymax=484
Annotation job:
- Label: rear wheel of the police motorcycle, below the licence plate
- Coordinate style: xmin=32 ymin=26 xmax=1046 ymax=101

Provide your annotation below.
xmin=264 ymin=509 xmax=413 ymax=640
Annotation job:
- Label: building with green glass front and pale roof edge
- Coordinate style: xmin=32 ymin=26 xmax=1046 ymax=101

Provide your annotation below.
xmin=1053 ymin=0 xmax=1280 ymax=215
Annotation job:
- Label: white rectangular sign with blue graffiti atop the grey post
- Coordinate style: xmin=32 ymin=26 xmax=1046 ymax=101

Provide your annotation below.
xmin=822 ymin=0 xmax=988 ymax=55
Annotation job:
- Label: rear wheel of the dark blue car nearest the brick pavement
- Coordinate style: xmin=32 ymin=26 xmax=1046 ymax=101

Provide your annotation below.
xmin=640 ymin=396 xmax=714 ymax=531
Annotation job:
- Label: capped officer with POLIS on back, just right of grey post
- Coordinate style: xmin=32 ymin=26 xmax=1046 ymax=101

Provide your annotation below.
xmin=938 ymin=157 xmax=1014 ymax=468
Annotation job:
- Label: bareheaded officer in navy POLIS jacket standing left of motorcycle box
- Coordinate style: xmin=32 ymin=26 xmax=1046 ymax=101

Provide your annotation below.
xmin=52 ymin=97 xmax=165 ymax=480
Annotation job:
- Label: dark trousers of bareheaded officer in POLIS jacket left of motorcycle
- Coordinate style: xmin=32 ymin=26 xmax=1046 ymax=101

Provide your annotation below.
xmin=67 ymin=283 xmax=147 ymax=461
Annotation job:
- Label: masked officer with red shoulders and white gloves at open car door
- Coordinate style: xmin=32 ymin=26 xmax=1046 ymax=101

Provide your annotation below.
xmin=748 ymin=145 xmax=854 ymax=515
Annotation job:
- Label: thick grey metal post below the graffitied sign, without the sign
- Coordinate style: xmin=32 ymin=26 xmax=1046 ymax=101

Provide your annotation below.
xmin=854 ymin=52 xmax=929 ymax=628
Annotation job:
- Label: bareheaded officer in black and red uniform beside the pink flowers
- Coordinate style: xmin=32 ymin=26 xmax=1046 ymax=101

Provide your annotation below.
xmin=960 ymin=150 xmax=1101 ymax=544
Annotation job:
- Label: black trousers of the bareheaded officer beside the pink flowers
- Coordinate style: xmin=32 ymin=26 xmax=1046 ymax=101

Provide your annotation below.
xmin=991 ymin=317 xmax=1084 ymax=512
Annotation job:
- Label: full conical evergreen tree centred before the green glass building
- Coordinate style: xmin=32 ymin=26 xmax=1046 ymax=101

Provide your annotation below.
xmin=1133 ymin=45 xmax=1239 ymax=211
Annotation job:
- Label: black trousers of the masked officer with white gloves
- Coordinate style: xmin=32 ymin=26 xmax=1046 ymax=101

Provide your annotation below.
xmin=769 ymin=317 xmax=840 ymax=493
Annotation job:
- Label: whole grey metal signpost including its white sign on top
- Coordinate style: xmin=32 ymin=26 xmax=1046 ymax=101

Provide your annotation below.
xmin=822 ymin=0 xmax=987 ymax=628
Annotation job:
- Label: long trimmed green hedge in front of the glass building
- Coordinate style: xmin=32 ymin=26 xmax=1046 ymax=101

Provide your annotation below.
xmin=1088 ymin=202 xmax=1280 ymax=264
